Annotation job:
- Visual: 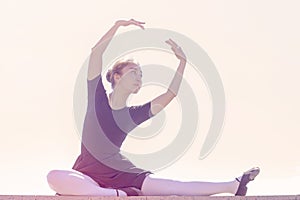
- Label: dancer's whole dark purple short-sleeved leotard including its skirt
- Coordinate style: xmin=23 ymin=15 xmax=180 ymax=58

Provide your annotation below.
xmin=73 ymin=75 xmax=153 ymax=194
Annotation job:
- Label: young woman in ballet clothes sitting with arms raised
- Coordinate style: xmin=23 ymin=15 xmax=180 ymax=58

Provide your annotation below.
xmin=47 ymin=19 xmax=259 ymax=196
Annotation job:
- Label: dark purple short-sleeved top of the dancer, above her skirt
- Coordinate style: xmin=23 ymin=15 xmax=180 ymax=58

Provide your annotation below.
xmin=82 ymin=75 xmax=153 ymax=160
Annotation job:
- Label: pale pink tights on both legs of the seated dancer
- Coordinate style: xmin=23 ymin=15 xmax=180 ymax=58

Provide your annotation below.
xmin=47 ymin=170 xmax=239 ymax=196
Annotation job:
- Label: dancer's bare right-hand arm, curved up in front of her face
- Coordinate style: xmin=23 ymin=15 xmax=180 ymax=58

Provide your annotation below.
xmin=151 ymin=39 xmax=186 ymax=115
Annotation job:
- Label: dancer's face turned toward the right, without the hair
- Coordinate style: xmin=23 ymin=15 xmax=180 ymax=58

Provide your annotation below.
xmin=116 ymin=63 xmax=142 ymax=94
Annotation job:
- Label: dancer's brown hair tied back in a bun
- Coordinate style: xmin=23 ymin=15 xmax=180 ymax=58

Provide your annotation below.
xmin=106 ymin=58 xmax=139 ymax=88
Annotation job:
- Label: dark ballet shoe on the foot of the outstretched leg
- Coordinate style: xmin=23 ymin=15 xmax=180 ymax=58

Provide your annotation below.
xmin=235 ymin=167 xmax=260 ymax=196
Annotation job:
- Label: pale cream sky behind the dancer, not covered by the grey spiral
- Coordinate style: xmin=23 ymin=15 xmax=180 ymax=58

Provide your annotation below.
xmin=0 ymin=0 xmax=300 ymax=195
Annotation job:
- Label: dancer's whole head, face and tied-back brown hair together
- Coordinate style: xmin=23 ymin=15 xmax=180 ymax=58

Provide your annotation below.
xmin=106 ymin=59 xmax=142 ymax=94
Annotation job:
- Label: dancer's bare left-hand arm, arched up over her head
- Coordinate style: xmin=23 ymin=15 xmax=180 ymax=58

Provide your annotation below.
xmin=88 ymin=19 xmax=145 ymax=80
